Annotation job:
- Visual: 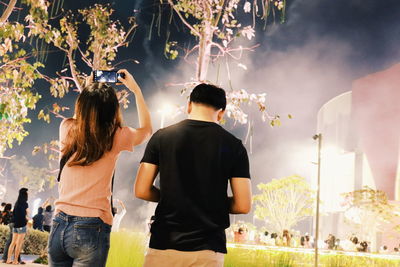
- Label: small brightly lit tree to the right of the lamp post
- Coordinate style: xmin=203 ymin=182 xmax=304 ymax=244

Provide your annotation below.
xmin=342 ymin=186 xmax=398 ymax=241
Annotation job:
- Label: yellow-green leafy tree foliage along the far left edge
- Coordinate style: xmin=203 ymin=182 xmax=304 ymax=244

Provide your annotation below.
xmin=0 ymin=0 xmax=48 ymax=159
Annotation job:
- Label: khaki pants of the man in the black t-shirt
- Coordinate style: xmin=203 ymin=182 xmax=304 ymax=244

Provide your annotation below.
xmin=143 ymin=248 xmax=225 ymax=267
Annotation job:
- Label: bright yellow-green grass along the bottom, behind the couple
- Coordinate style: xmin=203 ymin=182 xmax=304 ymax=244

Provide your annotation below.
xmin=107 ymin=231 xmax=400 ymax=267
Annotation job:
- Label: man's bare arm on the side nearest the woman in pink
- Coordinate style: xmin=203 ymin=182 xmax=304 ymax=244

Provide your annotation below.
xmin=133 ymin=162 xmax=160 ymax=202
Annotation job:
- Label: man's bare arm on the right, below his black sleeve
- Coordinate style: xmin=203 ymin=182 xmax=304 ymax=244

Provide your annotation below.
xmin=229 ymin=177 xmax=251 ymax=214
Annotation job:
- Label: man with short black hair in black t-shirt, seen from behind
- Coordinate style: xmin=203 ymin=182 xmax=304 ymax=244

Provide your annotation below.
xmin=134 ymin=84 xmax=251 ymax=267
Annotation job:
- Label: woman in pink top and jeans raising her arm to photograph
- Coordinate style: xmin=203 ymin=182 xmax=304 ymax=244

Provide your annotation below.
xmin=49 ymin=70 xmax=152 ymax=267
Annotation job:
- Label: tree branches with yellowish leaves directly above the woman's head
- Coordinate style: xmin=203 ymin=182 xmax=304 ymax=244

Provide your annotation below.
xmin=20 ymin=2 xmax=137 ymax=168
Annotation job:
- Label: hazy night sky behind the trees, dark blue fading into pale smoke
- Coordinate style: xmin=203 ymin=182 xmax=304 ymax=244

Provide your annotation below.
xmin=3 ymin=0 xmax=400 ymax=226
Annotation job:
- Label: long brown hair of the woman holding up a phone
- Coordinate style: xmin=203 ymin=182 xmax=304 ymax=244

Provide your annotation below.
xmin=62 ymin=83 xmax=122 ymax=166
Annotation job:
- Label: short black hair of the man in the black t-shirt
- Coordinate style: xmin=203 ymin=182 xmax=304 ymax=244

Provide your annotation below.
xmin=190 ymin=83 xmax=226 ymax=110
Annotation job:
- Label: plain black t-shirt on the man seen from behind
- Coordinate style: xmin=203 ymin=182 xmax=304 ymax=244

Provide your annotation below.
xmin=141 ymin=120 xmax=250 ymax=253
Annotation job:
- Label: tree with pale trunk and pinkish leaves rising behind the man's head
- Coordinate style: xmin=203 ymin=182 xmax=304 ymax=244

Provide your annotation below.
xmin=161 ymin=0 xmax=286 ymax=126
